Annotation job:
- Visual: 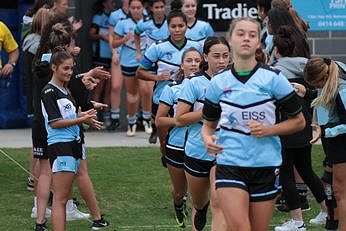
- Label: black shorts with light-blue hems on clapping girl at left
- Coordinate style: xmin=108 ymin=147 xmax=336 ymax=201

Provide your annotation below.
xmin=48 ymin=141 xmax=83 ymax=171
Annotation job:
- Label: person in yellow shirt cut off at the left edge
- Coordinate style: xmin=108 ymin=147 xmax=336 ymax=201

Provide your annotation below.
xmin=0 ymin=21 xmax=19 ymax=87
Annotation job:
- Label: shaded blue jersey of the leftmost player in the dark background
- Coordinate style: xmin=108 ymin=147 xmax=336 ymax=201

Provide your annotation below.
xmin=90 ymin=12 xmax=112 ymax=63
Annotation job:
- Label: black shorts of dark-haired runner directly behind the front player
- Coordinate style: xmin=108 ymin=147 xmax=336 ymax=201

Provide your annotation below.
xmin=184 ymin=155 xmax=215 ymax=177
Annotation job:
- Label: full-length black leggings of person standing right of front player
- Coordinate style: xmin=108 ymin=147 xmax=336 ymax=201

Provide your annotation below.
xmin=280 ymin=145 xmax=325 ymax=210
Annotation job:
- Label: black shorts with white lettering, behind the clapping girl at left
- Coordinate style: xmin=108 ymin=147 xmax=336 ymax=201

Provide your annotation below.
xmin=31 ymin=119 xmax=48 ymax=160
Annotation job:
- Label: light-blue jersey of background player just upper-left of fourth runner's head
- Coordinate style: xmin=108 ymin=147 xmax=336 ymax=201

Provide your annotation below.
xmin=135 ymin=17 xmax=169 ymax=47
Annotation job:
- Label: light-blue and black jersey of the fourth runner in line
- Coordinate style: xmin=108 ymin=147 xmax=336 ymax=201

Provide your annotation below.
xmin=140 ymin=37 xmax=202 ymax=104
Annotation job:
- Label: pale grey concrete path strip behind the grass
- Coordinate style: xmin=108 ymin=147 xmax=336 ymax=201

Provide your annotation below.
xmin=0 ymin=128 xmax=159 ymax=148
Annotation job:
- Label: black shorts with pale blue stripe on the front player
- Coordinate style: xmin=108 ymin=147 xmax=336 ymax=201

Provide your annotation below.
xmin=215 ymin=165 xmax=279 ymax=202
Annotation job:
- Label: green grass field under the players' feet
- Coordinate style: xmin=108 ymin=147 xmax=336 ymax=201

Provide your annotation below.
xmin=0 ymin=145 xmax=323 ymax=231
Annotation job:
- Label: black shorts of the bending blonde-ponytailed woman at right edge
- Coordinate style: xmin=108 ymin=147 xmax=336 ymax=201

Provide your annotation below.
xmin=323 ymin=134 xmax=346 ymax=164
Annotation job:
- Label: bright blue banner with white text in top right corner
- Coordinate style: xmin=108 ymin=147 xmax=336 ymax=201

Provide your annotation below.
xmin=292 ymin=0 xmax=346 ymax=31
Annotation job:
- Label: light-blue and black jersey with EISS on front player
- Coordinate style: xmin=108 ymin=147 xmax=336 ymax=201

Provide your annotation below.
xmin=203 ymin=64 xmax=302 ymax=167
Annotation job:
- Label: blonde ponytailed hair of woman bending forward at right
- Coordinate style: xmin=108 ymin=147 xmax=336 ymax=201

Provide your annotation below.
xmin=304 ymin=58 xmax=339 ymax=109
